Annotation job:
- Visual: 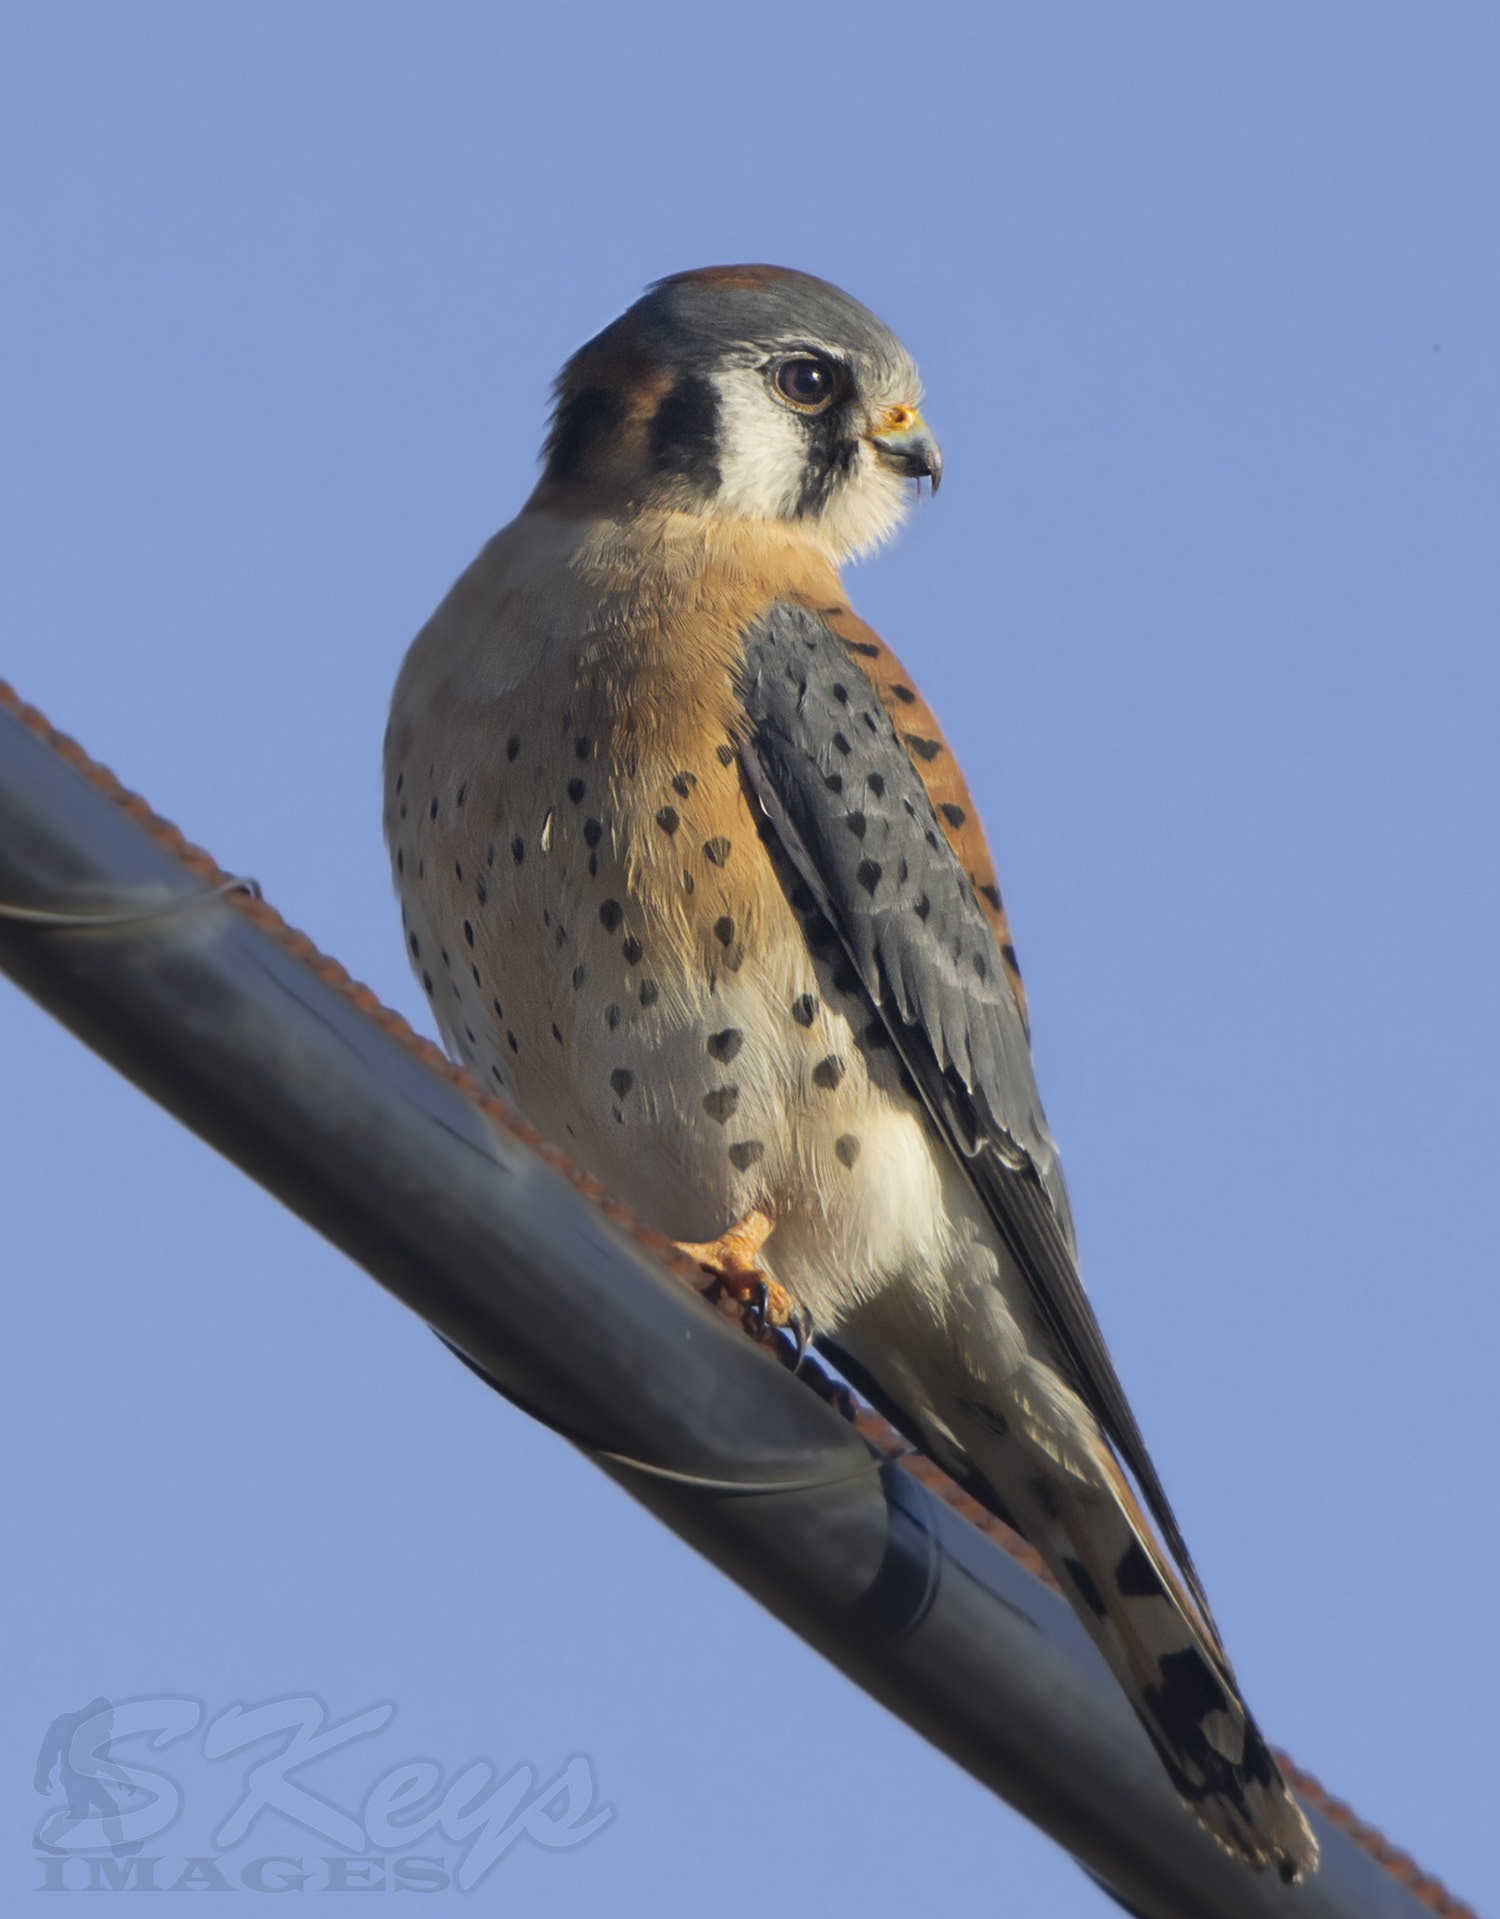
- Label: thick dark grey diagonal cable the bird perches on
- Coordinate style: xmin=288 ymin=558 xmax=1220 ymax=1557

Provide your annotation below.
xmin=0 ymin=683 xmax=1467 ymax=1919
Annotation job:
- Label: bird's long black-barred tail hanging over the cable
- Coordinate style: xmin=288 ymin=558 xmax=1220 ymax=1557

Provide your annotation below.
xmin=967 ymin=1435 xmax=1318 ymax=1881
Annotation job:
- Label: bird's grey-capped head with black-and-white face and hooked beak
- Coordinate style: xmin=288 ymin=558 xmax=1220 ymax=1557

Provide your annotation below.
xmin=533 ymin=267 xmax=942 ymax=562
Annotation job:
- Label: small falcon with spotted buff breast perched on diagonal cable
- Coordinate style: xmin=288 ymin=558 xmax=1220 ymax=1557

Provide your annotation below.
xmin=384 ymin=267 xmax=1318 ymax=1879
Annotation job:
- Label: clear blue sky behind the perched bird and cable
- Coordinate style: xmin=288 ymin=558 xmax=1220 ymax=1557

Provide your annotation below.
xmin=0 ymin=0 xmax=1500 ymax=1919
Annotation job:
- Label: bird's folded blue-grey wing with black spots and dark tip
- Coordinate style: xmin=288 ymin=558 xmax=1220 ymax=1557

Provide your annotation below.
xmin=738 ymin=603 xmax=1207 ymax=1612
